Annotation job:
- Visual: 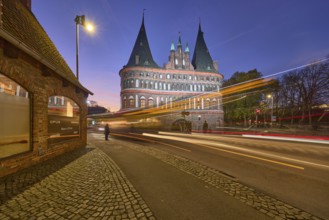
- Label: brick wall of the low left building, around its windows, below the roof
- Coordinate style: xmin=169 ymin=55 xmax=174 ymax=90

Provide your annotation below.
xmin=0 ymin=40 xmax=87 ymax=177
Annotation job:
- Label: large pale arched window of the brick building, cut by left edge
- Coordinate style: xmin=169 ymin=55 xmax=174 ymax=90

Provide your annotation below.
xmin=0 ymin=74 xmax=31 ymax=159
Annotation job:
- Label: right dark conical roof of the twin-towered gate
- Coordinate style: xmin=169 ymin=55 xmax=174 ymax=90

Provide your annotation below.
xmin=192 ymin=24 xmax=217 ymax=73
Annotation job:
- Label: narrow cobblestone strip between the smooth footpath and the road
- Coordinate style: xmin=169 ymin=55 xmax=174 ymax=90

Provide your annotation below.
xmin=121 ymin=139 xmax=320 ymax=220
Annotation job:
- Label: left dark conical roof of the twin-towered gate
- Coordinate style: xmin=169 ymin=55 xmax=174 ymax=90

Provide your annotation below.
xmin=126 ymin=14 xmax=158 ymax=68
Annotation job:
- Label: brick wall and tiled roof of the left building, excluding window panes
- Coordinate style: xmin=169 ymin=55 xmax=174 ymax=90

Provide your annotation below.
xmin=0 ymin=0 xmax=92 ymax=177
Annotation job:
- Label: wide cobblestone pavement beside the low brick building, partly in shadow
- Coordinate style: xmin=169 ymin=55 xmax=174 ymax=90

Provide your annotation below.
xmin=0 ymin=147 xmax=155 ymax=220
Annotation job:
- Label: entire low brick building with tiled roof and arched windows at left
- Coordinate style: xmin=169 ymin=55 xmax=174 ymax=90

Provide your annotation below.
xmin=0 ymin=0 xmax=92 ymax=176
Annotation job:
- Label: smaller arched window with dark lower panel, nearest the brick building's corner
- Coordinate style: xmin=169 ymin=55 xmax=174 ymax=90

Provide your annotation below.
xmin=48 ymin=96 xmax=80 ymax=145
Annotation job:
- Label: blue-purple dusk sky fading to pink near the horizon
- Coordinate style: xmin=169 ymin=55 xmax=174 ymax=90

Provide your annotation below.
xmin=32 ymin=0 xmax=329 ymax=111
